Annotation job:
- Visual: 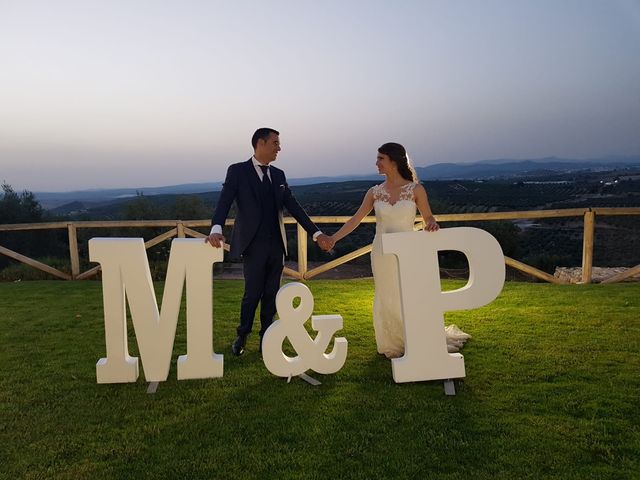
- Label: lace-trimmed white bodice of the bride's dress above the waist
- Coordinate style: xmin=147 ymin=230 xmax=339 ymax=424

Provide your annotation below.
xmin=373 ymin=183 xmax=417 ymax=235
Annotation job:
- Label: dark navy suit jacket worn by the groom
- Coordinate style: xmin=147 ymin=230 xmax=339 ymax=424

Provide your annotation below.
xmin=212 ymin=159 xmax=318 ymax=258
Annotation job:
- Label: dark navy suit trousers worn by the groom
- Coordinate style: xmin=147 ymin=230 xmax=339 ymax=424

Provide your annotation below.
xmin=237 ymin=235 xmax=284 ymax=337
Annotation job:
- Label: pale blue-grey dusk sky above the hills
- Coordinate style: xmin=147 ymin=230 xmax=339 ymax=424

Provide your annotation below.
xmin=0 ymin=0 xmax=640 ymax=191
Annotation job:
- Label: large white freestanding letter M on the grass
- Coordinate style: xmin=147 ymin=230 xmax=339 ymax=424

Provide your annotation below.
xmin=89 ymin=238 xmax=223 ymax=383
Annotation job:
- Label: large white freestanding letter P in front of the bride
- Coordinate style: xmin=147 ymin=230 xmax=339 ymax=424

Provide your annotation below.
xmin=382 ymin=227 xmax=505 ymax=383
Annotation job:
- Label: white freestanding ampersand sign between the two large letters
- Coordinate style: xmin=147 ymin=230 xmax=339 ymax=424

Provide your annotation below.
xmin=262 ymin=282 xmax=347 ymax=377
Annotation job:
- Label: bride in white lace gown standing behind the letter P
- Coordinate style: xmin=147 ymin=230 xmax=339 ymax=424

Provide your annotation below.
xmin=331 ymin=143 xmax=470 ymax=358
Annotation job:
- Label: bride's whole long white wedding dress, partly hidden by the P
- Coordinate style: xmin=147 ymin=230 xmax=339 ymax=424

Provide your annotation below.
xmin=371 ymin=183 xmax=471 ymax=358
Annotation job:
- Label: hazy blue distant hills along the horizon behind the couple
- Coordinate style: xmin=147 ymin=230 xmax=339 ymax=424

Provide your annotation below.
xmin=35 ymin=156 xmax=640 ymax=209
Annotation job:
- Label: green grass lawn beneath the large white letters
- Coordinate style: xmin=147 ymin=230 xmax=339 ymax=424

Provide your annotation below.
xmin=0 ymin=280 xmax=640 ymax=479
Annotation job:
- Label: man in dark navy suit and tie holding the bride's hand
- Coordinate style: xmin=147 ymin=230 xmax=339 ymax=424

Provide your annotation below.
xmin=205 ymin=128 xmax=333 ymax=355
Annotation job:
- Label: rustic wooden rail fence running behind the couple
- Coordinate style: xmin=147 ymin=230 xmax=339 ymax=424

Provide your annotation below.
xmin=0 ymin=207 xmax=640 ymax=283
